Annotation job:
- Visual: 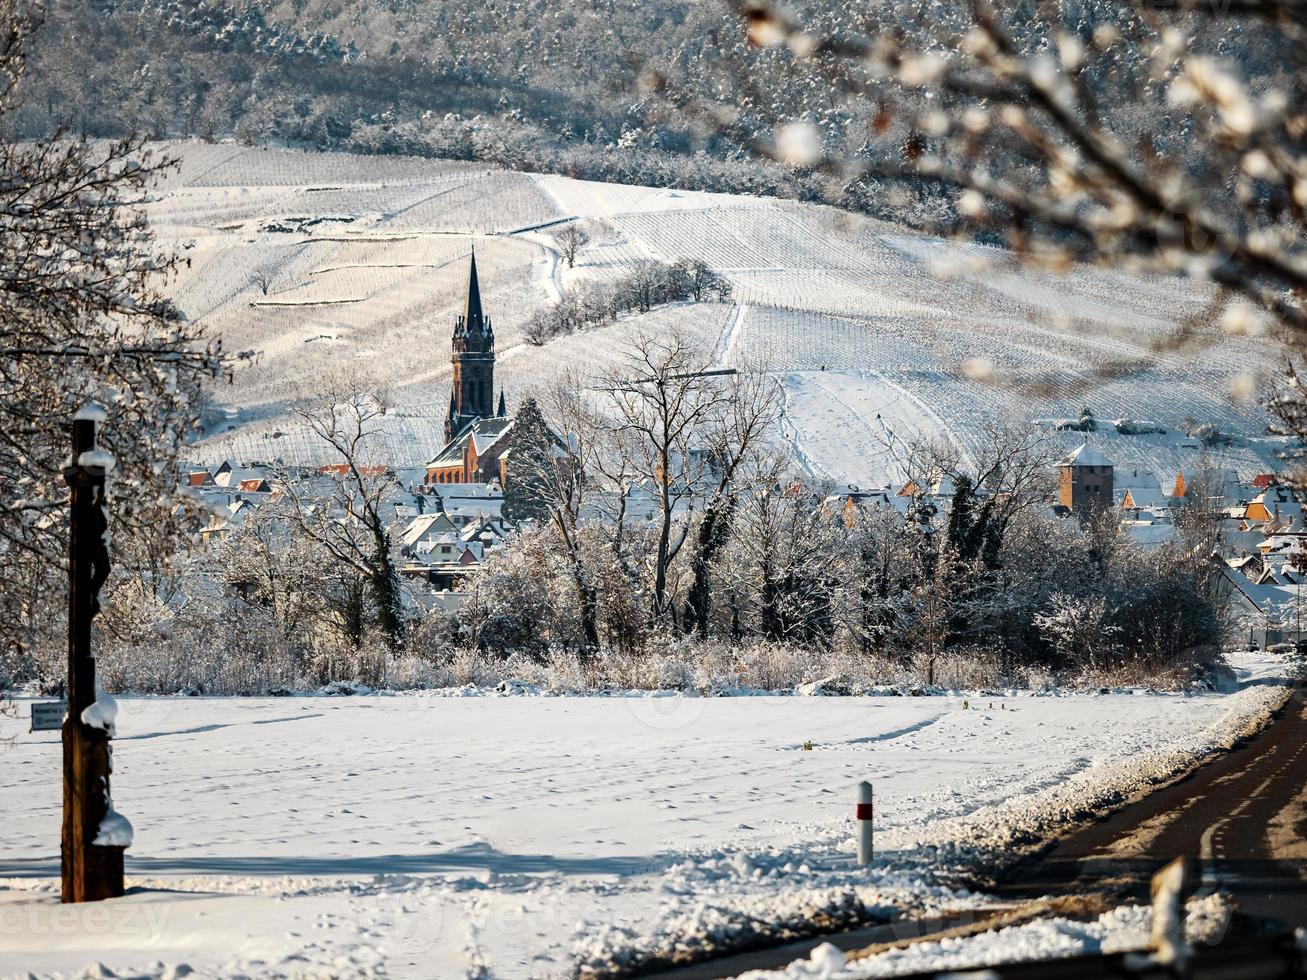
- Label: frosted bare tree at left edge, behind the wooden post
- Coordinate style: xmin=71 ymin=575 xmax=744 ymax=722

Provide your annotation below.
xmin=0 ymin=4 xmax=222 ymax=656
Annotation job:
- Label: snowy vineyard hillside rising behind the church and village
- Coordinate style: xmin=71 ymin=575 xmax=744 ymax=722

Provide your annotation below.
xmin=149 ymin=144 xmax=1274 ymax=485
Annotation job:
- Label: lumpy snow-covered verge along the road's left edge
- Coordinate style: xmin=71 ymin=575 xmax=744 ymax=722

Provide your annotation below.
xmin=574 ymin=679 xmax=1293 ymax=977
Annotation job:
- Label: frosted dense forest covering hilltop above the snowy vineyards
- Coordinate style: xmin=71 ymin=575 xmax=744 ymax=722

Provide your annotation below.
xmin=12 ymin=0 xmax=1278 ymax=223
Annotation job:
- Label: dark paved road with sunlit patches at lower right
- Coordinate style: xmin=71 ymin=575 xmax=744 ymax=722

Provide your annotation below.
xmin=1000 ymin=686 xmax=1307 ymax=926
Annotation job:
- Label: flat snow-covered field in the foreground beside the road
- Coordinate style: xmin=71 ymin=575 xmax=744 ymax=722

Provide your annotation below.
xmin=0 ymin=655 xmax=1282 ymax=977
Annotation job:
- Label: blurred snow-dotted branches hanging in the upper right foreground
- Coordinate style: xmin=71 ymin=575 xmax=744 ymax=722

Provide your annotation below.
xmin=736 ymin=0 xmax=1307 ymax=332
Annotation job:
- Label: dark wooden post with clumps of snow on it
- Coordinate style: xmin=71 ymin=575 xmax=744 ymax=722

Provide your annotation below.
xmin=60 ymin=405 xmax=131 ymax=902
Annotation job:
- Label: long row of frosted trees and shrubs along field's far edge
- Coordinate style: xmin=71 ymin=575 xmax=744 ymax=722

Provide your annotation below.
xmin=0 ymin=335 xmax=1226 ymax=694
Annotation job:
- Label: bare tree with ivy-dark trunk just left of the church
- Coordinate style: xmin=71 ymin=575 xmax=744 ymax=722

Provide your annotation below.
xmin=286 ymin=378 xmax=404 ymax=645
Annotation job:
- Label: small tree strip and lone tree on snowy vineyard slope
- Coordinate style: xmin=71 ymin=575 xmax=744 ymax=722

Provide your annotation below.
xmin=524 ymin=258 xmax=731 ymax=345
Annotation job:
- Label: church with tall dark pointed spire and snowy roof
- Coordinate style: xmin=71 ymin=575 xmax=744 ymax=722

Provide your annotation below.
xmin=426 ymin=250 xmax=512 ymax=486
